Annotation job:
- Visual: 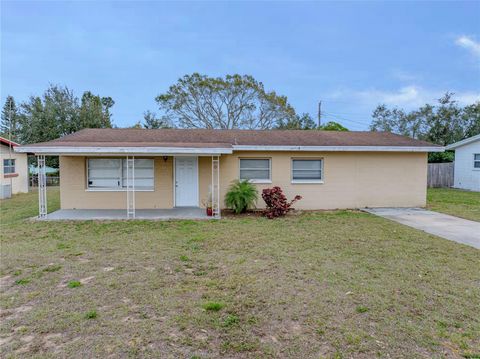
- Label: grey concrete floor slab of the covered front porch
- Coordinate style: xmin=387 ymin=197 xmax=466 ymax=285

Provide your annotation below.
xmin=40 ymin=207 xmax=212 ymax=221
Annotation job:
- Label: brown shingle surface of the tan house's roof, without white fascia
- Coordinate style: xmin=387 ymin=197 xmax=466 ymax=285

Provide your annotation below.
xmin=26 ymin=128 xmax=440 ymax=148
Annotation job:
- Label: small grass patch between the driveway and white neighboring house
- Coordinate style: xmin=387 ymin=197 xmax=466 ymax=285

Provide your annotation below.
xmin=427 ymin=188 xmax=480 ymax=222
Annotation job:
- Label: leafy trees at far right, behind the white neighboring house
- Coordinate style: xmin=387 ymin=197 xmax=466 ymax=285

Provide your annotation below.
xmin=370 ymin=92 xmax=480 ymax=161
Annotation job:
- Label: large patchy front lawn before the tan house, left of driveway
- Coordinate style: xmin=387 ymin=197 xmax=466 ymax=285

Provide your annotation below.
xmin=0 ymin=191 xmax=480 ymax=358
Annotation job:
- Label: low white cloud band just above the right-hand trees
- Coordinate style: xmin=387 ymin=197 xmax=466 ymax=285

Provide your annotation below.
xmin=333 ymin=85 xmax=480 ymax=109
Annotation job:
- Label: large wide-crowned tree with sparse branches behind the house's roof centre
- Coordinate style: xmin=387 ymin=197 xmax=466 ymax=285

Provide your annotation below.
xmin=156 ymin=73 xmax=295 ymax=129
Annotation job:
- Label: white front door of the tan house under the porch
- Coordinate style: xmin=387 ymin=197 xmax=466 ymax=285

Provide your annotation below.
xmin=175 ymin=157 xmax=198 ymax=207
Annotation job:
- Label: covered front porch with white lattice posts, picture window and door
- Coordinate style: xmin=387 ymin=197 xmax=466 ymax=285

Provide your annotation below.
xmin=38 ymin=154 xmax=221 ymax=220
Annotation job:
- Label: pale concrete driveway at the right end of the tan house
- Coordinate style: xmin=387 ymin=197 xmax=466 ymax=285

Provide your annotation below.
xmin=364 ymin=208 xmax=480 ymax=249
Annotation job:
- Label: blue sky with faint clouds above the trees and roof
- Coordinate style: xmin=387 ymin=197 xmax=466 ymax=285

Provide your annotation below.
xmin=1 ymin=1 xmax=480 ymax=130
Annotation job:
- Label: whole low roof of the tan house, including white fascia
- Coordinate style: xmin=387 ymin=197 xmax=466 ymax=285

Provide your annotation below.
xmin=17 ymin=128 xmax=444 ymax=153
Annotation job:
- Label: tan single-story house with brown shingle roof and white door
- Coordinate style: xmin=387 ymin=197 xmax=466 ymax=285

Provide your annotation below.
xmin=16 ymin=129 xmax=444 ymax=217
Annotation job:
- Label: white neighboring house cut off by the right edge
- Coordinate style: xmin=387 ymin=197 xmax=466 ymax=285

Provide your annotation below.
xmin=446 ymin=134 xmax=480 ymax=191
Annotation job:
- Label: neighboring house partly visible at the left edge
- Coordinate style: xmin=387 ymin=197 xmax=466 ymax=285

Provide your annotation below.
xmin=0 ymin=137 xmax=28 ymax=198
